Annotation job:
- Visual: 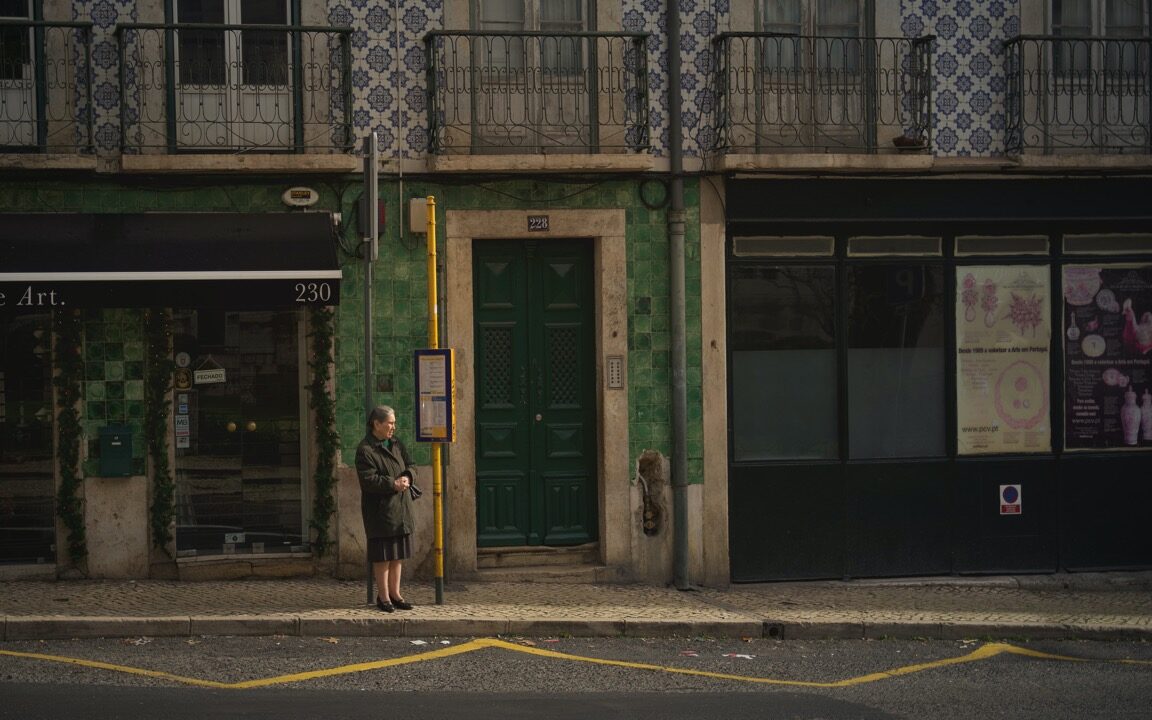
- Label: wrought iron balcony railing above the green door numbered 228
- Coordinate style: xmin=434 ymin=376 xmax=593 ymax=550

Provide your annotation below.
xmin=424 ymin=31 xmax=650 ymax=154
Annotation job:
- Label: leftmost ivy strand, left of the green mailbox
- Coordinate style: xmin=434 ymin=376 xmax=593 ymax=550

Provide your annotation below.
xmin=52 ymin=310 xmax=88 ymax=563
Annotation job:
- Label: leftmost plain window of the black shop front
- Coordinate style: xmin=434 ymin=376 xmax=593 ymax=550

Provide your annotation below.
xmin=732 ymin=265 xmax=839 ymax=461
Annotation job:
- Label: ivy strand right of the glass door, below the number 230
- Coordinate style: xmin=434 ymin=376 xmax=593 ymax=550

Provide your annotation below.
xmin=308 ymin=308 xmax=340 ymax=555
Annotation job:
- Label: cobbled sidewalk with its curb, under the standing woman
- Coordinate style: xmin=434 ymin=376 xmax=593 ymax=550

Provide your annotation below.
xmin=0 ymin=573 xmax=1152 ymax=641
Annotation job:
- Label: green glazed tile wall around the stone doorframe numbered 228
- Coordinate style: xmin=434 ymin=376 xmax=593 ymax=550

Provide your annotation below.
xmin=336 ymin=180 xmax=703 ymax=482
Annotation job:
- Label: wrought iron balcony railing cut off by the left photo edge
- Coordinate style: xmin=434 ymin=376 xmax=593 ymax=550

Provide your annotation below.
xmin=0 ymin=20 xmax=92 ymax=153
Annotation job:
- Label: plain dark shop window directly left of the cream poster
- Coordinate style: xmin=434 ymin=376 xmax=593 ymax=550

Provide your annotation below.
xmin=844 ymin=264 xmax=946 ymax=458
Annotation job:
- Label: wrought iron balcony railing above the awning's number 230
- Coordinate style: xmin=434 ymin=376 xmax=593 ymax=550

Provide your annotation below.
xmin=116 ymin=23 xmax=355 ymax=153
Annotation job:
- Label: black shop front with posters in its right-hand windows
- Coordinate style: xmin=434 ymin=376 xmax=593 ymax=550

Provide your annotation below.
xmin=727 ymin=176 xmax=1152 ymax=582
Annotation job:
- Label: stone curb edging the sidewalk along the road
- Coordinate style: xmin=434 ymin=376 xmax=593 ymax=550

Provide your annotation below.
xmin=9 ymin=615 xmax=1152 ymax=642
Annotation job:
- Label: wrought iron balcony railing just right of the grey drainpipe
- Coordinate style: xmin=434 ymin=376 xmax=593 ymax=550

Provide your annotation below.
xmin=713 ymin=32 xmax=934 ymax=153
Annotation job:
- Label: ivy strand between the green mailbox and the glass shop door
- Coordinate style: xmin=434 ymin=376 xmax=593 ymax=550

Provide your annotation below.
xmin=144 ymin=309 xmax=176 ymax=556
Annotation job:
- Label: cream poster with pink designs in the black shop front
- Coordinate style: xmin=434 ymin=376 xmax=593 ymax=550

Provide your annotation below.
xmin=956 ymin=265 xmax=1052 ymax=455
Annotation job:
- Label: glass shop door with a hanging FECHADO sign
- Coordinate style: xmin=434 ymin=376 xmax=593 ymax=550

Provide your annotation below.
xmin=173 ymin=310 xmax=305 ymax=556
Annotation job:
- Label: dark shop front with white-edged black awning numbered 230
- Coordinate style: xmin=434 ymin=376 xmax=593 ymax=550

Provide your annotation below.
xmin=0 ymin=212 xmax=341 ymax=569
